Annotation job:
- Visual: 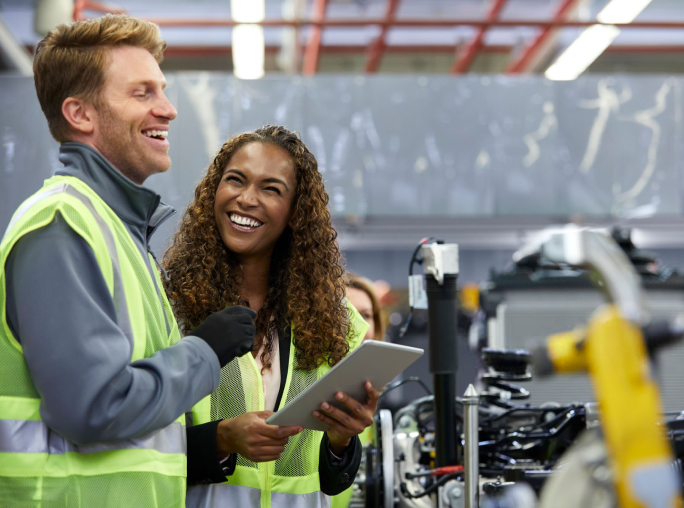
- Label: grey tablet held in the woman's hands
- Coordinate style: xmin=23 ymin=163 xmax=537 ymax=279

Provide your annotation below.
xmin=266 ymin=340 xmax=424 ymax=431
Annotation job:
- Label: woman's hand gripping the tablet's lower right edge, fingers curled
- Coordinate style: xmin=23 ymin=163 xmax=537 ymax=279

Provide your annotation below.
xmin=313 ymin=381 xmax=378 ymax=455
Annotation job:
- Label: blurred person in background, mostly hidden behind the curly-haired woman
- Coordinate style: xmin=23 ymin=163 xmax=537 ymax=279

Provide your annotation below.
xmin=332 ymin=272 xmax=385 ymax=508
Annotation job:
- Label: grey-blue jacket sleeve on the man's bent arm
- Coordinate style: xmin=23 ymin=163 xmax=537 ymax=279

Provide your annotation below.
xmin=5 ymin=215 xmax=221 ymax=444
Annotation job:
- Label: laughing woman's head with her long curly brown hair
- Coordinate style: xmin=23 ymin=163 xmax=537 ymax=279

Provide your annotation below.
xmin=164 ymin=126 xmax=349 ymax=369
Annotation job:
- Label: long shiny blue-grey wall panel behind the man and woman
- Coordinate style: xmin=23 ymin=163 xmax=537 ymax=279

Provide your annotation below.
xmin=0 ymin=72 xmax=684 ymax=248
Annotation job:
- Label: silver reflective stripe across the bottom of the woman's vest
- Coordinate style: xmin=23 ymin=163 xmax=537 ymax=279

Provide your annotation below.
xmin=186 ymin=483 xmax=331 ymax=508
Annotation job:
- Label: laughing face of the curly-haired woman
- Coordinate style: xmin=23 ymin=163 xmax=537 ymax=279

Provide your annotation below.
xmin=214 ymin=143 xmax=296 ymax=260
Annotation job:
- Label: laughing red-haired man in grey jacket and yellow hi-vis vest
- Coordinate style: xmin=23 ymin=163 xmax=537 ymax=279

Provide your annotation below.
xmin=0 ymin=15 xmax=254 ymax=508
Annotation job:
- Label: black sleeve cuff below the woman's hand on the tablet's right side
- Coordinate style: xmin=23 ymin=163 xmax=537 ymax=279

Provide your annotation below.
xmin=318 ymin=433 xmax=363 ymax=496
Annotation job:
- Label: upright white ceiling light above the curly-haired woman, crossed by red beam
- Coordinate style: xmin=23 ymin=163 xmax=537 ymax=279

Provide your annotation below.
xmin=230 ymin=0 xmax=266 ymax=79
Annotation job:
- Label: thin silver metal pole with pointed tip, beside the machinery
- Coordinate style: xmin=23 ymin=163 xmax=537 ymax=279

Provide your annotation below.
xmin=463 ymin=384 xmax=480 ymax=508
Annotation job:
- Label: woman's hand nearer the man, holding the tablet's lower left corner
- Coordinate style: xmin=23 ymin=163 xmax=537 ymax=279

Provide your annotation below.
xmin=216 ymin=411 xmax=304 ymax=462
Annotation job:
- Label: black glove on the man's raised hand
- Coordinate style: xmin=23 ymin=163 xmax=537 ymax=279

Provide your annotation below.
xmin=188 ymin=305 xmax=256 ymax=367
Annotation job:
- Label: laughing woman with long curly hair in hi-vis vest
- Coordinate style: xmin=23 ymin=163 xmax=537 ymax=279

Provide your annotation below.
xmin=164 ymin=126 xmax=378 ymax=507
